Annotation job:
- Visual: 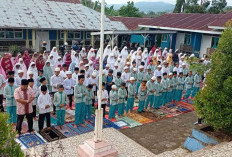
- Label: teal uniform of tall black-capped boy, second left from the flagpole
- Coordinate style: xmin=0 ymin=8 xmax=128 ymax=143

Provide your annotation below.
xmin=74 ymin=83 xmax=86 ymax=125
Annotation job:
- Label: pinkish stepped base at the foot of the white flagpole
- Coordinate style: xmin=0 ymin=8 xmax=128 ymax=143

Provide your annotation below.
xmin=78 ymin=139 xmax=118 ymax=157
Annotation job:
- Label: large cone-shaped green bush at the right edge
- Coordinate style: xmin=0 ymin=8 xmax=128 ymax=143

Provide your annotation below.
xmin=194 ymin=21 xmax=232 ymax=132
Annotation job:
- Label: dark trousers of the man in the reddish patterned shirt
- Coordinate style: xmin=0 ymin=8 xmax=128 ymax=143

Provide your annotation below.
xmin=16 ymin=113 xmax=33 ymax=134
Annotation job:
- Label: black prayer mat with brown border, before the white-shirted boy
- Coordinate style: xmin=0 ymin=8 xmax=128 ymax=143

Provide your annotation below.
xmin=40 ymin=126 xmax=66 ymax=142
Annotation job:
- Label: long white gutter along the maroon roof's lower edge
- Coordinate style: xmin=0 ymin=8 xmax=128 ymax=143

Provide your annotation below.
xmin=139 ymin=25 xmax=222 ymax=35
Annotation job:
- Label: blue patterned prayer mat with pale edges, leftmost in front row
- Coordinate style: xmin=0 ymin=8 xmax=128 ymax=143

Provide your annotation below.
xmin=16 ymin=132 xmax=46 ymax=148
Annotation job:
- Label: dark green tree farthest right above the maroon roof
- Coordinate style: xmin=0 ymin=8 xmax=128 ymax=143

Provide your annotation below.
xmin=209 ymin=0 xmax=227 ymax=14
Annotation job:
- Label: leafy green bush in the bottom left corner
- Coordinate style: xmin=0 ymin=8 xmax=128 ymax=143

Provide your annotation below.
xmin=0 ymin=113 xmax=24 ymax=157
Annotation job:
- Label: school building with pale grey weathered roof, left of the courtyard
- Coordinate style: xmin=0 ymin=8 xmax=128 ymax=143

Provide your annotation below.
xmin=0 ymin=0 xmax=128 ymax=52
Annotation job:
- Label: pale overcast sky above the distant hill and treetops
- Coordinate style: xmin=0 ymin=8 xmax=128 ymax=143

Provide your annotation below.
xmin=104 ymin=0 xmax=232 ymax=6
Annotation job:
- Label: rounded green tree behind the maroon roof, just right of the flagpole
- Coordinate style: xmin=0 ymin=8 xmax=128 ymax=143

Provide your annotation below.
xmin=118 ymin=1 xmax=142 ymax=17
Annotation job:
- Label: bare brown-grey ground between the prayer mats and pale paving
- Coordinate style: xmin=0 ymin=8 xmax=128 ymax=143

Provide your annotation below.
xmin=120 ymin=112 xmax=197 ymax=154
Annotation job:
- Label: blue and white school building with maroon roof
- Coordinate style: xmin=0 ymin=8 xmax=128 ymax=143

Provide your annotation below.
xmin=110 ymin=11 xmax=232 ymax=57
